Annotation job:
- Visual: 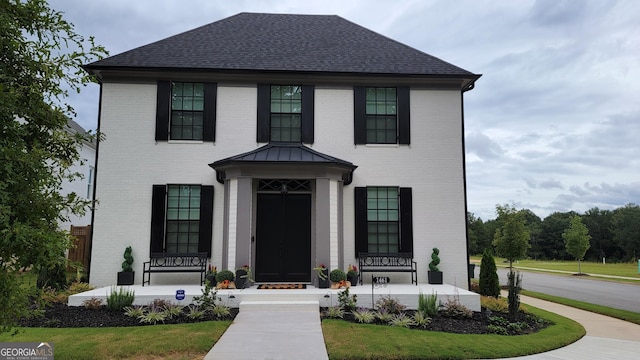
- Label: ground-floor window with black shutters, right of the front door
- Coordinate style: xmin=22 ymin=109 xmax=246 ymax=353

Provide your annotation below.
xmin=355 ymin=186 xmax=413 ymax=255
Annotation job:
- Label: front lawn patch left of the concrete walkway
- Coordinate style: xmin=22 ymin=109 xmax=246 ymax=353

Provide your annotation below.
xmin=0 ymin=321 xmax=231 ymax=359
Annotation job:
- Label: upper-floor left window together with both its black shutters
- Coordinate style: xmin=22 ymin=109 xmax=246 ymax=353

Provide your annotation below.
xmin=155 ymin=81 xmax=217 ymax=141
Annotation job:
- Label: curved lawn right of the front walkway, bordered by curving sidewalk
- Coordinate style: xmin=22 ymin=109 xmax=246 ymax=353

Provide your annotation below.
xmin=322 ymin=306 xmax=585 ymax=360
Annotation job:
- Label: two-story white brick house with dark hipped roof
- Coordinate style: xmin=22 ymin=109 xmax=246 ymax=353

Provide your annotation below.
xmin=85 ymin=13 xmax=480 ymax=288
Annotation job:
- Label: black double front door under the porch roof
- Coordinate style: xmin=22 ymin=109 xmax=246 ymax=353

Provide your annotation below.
xmin=255 ymin=193 xmax=311 ymax=282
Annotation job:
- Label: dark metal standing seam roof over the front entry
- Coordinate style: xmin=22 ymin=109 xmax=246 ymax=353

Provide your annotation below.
xmin=209 ymin=142 xmax=357 ymax=185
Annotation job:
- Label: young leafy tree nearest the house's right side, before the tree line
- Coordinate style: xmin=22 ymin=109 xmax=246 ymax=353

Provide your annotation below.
xmin=493 ymin=205 xmax=530 ymax=270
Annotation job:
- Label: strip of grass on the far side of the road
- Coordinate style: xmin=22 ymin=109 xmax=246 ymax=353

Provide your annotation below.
xmin=471 ymin=256 xmax=640 ymax=281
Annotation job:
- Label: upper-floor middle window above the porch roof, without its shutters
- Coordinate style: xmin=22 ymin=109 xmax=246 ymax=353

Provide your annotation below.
xmin=270 ymin=85 xmax=302 ymax=142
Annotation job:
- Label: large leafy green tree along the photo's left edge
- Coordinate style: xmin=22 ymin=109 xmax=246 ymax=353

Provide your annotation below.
xmin=0 ymin=0 xmax=106 ymax=331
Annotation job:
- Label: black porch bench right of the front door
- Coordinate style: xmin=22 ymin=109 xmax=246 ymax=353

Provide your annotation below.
xmin=358 ymin=253 xmax=418 ymax=285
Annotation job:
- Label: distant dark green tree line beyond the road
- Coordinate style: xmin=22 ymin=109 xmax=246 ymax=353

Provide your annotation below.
xmin=467 ymin=204 xmax=640 ymax=262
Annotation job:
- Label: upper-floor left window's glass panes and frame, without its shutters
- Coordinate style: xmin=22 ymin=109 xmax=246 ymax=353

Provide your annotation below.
xmin=169 ymin=82 xmax=204 ymax=140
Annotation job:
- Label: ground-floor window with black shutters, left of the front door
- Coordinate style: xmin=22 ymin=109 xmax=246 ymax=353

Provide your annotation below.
xmin=151 ymin=184 xmax=213 ymax=256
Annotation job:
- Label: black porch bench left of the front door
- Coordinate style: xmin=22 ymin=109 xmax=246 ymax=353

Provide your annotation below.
xmin=142 ymin=252 xmax=208 ymax=286
